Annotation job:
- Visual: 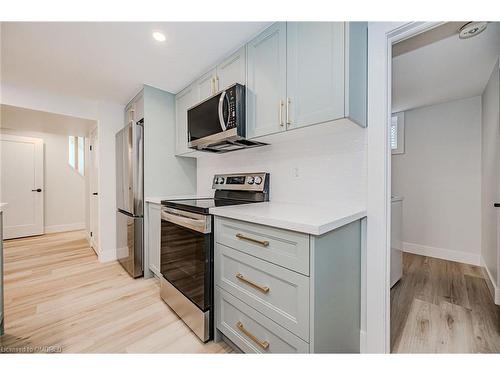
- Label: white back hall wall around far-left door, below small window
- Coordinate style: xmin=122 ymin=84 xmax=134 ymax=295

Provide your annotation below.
xmin=1 ymin=128 xmax=87 ymax=233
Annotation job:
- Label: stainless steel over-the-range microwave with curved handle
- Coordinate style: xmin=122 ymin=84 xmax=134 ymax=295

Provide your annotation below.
xmin=187 ymin=83 xmax=265 ymax=153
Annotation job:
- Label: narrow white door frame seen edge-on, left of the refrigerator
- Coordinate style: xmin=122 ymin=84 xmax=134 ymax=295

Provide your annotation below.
xmin=88 ymin=125 xmax=100 ymax=256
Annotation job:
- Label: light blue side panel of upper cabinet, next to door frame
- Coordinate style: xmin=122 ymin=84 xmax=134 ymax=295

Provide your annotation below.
xmin=345 ymin=22 xmax=368 ymax=127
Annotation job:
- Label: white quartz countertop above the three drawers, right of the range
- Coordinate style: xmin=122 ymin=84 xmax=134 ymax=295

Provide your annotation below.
xmin=210 ymin=202 xmax=366 ymax=236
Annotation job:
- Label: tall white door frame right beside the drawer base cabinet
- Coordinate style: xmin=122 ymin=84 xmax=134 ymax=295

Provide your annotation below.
xmin=361 ymin=22 xmax=443 ymax=353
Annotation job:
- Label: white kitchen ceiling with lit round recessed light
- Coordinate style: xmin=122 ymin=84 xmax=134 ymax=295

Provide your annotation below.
xmin=1 ymin=22 xmax=269 ymax=104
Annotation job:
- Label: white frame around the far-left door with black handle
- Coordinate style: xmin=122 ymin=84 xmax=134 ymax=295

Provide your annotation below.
xmin=0 ymin=133 xmax=45 ymax=238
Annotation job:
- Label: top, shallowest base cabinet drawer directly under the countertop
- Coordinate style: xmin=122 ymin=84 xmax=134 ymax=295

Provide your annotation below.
xmin=215 ymin=217 xmax=309 ymax=275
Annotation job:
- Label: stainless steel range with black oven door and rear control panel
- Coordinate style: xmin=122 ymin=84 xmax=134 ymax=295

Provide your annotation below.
xmin=160 ymin=173 xmax=269 ymax=342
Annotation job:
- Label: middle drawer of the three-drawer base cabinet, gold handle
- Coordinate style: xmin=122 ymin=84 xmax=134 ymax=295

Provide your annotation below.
xmin=215 ymin=244 xmax=309 ymax=341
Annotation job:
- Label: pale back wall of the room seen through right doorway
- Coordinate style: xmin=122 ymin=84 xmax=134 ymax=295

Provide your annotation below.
xmin=392 ymin=96 xmax=481 ymax=264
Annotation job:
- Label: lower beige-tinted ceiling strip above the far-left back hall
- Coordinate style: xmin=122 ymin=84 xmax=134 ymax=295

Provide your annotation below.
xmin=0 ymin=104 xmax=96 ymax=137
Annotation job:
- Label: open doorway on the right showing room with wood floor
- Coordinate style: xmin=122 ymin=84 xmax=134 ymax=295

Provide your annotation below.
xmin=386 ymin=22 xmax=500 ymax=353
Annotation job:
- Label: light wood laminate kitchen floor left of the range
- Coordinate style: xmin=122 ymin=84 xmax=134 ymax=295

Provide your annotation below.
xmin=0 ymin=231 xmax=231 ymax=353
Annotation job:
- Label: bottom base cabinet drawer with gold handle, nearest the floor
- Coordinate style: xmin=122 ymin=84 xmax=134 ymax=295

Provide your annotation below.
xmin=216 ymin=287 xmax=309 ymax=353
